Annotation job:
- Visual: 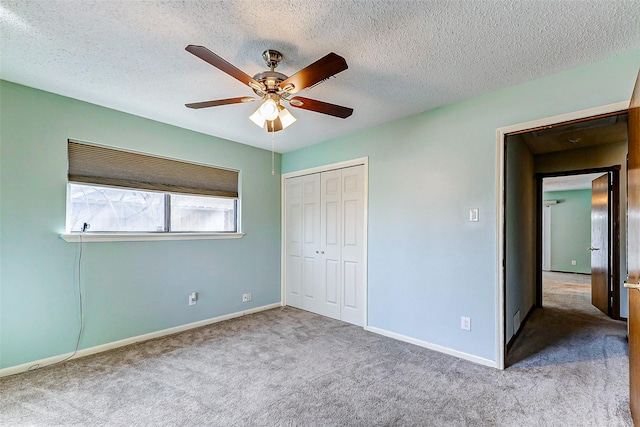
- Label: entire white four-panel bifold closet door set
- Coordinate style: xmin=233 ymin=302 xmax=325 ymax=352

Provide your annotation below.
xmin=285 ymin=166 xmax=366 ymax=326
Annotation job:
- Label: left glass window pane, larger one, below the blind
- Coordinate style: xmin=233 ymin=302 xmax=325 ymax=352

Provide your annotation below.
xmin=68 ymin=184 xmax=164 ymax=232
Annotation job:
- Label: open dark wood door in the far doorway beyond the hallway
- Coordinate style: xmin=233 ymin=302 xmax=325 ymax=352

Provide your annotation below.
xmin=589 ymin=173 xmax=611 ymax=316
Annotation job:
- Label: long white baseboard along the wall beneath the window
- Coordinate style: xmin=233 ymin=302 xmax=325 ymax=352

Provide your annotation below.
xmin=0 ymin=302 xmax=282 ymax=378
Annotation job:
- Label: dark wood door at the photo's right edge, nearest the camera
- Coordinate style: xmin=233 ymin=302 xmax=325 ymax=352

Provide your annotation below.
xmin=625 ymin=69 xmax=640 ymax=426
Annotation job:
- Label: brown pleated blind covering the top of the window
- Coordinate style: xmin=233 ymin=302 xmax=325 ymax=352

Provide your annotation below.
xmin=68 ymin=140 xmax=238 ymax=198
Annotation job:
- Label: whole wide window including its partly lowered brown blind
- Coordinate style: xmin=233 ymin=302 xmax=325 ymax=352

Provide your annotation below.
xmin=66 ymin=141 xmax=238 ymax=233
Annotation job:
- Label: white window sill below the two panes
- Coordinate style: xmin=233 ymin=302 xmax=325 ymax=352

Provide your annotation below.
xmin=60 ymin=233 xmax=244 ymax=243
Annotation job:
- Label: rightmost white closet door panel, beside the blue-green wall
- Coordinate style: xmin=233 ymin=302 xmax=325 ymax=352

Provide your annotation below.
xmin=340 ymin=166 xmax=366 ymax=326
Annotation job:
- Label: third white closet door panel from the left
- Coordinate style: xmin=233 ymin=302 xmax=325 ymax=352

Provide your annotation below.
xmin=318 ymin=170 xmax=342 ymax=319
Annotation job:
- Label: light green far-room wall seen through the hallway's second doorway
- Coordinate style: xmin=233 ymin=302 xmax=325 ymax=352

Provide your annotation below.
xmin=544 ymin=190 xmax=591 ymax=274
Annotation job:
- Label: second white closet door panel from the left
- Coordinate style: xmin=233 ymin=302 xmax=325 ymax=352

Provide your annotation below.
xmin=302 ymin=174 xmax=323 ymax=314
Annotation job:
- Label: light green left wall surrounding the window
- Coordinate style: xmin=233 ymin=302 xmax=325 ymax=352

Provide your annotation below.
xmin=0 ymin=81 xmax=280 ymax=367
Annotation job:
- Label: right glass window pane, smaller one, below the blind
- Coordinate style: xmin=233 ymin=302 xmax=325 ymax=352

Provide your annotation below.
xmin=171 ymin=194 xmax=236 ymax=232
